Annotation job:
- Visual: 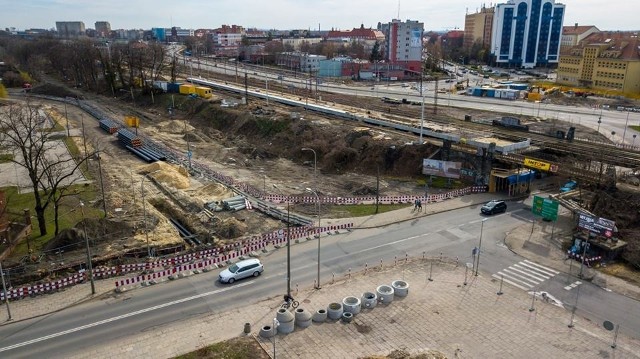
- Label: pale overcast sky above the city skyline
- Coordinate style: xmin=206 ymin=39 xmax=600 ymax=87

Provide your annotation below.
xmin=0 ymin=0 xmax=640 ymax=31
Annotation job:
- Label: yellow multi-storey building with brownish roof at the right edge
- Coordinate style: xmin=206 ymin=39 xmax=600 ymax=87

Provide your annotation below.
xmin=556 ymin=32 xmax=640 ymax=95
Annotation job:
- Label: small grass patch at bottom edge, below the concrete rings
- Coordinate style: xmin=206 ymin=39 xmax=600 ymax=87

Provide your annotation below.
xmin=176 ymin=337 xmax=269 ymax=359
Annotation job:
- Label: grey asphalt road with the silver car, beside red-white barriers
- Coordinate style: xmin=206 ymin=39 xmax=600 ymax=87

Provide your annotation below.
xmin=0 ymin=204 xmax=640 ymax=358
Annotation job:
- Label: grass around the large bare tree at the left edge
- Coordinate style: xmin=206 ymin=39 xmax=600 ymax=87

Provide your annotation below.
xmin=3 ymin=185 xmax=102 ymax=257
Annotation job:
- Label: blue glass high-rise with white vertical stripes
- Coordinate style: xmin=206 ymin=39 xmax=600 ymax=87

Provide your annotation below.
xmin=491 ymin=0 xmax=565 ymax=68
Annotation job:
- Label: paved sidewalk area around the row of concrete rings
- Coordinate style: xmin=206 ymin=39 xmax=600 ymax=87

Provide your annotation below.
xmin=63 ymin=259 xmax=640 ymax=359
